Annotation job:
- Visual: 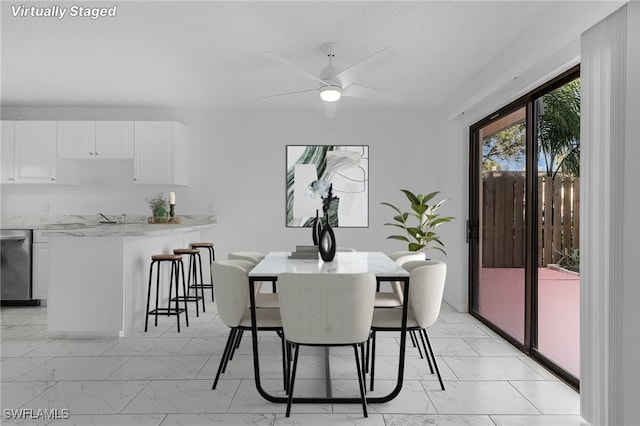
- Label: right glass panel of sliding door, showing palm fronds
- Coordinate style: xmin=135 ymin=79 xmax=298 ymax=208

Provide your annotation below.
xmin=535 ymin=80 xmax=580 ymax=378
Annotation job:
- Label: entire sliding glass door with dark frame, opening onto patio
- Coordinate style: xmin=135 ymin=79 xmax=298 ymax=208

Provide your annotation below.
xmin=469 ymin=68 xmax=580 ymax=387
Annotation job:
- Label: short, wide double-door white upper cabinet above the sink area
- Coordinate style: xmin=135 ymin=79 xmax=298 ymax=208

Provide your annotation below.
xmin=58 ymin=121 xmax=133 ymax=160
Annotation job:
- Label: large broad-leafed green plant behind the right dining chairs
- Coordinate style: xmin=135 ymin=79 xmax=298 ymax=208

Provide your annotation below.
xmin=381 ymin=189 xmax=454 ymax=255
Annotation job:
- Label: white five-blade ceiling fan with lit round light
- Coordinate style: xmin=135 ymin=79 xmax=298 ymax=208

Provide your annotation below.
xmin=260 ymin=42 xmax=404 ymax=117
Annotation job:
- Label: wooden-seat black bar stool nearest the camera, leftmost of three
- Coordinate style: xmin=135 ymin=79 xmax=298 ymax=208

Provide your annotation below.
xmin=144 ymin=254 xmax=189 ymax=333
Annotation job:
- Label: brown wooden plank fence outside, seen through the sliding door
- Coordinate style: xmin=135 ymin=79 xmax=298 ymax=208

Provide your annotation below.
xmin=482 ymin=172 xmax=580 ymax=268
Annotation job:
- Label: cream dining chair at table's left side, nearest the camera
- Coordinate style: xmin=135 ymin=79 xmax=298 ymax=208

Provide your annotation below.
xmin=212 ymin=260 xmax=288 ymax=389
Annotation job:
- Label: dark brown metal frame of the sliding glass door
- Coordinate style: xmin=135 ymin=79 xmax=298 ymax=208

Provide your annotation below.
xmin=467 ymin=65 xmax=580 ymax=390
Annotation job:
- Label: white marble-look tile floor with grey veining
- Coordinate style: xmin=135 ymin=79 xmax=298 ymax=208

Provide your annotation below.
xmin=0 ymin=302 xmax=586 ymax=426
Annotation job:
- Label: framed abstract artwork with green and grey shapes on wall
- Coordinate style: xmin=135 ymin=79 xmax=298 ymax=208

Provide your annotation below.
xmin=286 ymin=145 xmax=369 ymax=228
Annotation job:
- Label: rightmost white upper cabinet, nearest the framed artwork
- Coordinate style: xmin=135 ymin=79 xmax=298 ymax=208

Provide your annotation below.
xmin=133 ymin=121 xmax=189 ymax=185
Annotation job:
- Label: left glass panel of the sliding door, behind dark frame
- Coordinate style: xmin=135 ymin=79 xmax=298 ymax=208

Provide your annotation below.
xmin=476 ymin=107 xmax=526 ymax=343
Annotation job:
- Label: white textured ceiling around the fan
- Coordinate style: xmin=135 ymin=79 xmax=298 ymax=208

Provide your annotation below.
xmin=1 ymin=1 xmax=616 ymax=108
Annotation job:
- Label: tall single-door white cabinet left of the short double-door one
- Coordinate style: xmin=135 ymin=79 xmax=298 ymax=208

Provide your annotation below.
xmin=14 ymin=121 xmax=57 ymax=183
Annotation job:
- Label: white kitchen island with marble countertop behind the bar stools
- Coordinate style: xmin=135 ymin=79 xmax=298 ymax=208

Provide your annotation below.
xmin=47 ymin=223 xmax=213 ymax=337
